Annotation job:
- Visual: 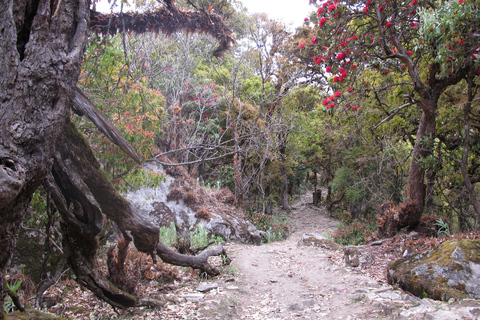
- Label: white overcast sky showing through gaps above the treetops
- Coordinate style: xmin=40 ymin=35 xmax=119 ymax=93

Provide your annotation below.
xmin=97 ymin=0 xmax=314 ymax=27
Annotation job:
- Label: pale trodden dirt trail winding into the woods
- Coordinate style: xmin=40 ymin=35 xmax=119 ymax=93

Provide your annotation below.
xmin=199 ymin=195 xmax=400 ymax=319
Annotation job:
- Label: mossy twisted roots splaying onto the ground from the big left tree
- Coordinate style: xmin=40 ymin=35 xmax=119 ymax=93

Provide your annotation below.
xmin=45 ymin=121 xmax=225 ymax=308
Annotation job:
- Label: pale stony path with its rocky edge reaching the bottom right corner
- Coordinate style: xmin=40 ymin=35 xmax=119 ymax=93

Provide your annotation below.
xmin=195 ymin=192 xmax=480 ymax=320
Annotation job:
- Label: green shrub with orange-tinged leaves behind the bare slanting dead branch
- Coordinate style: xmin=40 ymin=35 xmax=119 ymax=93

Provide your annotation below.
xmin=76 ymin=35 xmax=165 ymax=178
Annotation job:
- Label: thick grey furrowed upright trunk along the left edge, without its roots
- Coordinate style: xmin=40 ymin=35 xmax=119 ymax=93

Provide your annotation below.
xmin=0 ymin=0 xmax=89 ymax=318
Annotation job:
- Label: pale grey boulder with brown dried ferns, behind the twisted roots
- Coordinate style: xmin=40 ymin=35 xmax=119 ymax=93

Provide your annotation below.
xmin=124 ymin=161 xmax=261 ymax=244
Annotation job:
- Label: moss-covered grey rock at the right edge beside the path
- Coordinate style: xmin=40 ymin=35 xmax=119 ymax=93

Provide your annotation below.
xmin=387 ymin=239 xmax=480 ymax=301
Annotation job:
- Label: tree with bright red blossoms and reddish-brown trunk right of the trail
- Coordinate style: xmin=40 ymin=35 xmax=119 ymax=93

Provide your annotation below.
xmin=299 ymin=0 xmax=480 ymax=229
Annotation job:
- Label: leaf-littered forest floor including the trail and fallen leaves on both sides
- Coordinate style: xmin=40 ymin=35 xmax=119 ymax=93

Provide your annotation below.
xmin=41 ymin=191 xmax=475 ymax=320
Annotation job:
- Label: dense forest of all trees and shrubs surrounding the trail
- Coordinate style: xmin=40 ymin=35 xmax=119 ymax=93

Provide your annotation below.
xmin=0 ymin=0 xmax=480 ymax=319
